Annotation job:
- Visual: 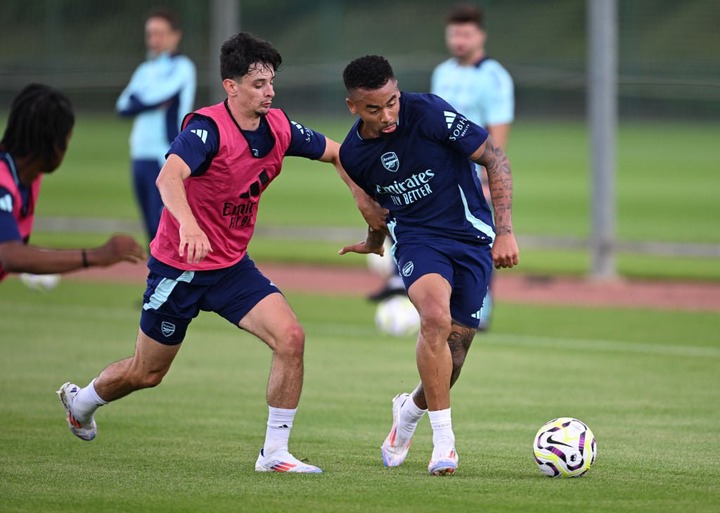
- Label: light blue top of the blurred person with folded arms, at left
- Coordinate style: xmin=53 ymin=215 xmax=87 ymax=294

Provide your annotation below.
xmin=115 ymin=53 xmax=197 ymax=164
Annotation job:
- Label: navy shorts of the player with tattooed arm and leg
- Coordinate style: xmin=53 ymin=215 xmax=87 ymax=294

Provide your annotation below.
xmin=393 ymin=239 xmax=493 ymax=328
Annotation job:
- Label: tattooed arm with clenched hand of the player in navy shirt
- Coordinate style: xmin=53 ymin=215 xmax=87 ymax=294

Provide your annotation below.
xmin=470 ymin=137 xmax=519 ymax=269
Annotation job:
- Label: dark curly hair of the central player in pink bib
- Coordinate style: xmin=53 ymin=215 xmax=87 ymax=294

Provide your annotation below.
xmin=220 ymin=32 xmax=282 ymax=80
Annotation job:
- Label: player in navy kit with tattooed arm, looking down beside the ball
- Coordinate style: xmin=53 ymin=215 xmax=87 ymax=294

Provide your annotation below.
xmin=340 ymin=55 xmax=518 ymax=475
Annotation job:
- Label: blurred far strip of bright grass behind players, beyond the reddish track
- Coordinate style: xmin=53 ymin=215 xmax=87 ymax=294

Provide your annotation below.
xmin=21 ymin=115 xmax=720 ymax=280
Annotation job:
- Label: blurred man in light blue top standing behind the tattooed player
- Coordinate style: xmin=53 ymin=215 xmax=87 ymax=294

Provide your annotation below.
xmin=369 ymin=4 xmax=515 ymax=330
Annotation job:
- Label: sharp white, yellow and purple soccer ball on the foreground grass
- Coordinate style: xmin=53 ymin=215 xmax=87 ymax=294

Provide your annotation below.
xmin=533 ymin=417 xmax=597 ymax=477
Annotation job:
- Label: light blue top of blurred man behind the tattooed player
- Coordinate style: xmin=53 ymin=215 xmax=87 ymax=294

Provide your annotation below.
xmin=431 ymin=57 xmax=515 ymax=128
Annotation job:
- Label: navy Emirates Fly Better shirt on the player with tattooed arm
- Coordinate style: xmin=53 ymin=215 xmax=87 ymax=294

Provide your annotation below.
xmin=340 ymin=93 xmax=495 ymax=244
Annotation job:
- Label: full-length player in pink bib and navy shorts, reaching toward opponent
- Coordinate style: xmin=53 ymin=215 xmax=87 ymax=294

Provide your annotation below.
xmin=58 ymin=33 xmax=379 ymax=473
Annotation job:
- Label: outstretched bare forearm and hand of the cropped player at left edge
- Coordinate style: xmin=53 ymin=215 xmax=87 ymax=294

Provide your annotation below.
xmin=0 ymin=234 xmax=145 ymax=274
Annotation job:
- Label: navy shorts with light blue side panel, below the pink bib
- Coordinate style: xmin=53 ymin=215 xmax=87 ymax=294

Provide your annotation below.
xmin=140 ymin=254 xmax=280 ymax=345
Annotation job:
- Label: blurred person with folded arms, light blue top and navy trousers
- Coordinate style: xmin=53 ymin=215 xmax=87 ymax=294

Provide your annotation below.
xmin=115 ymin=9 xmax=196 ymax=242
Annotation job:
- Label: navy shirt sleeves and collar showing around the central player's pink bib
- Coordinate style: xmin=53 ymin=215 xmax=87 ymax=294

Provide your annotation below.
xmin=167 ymin=114 xmax=326 ymax=176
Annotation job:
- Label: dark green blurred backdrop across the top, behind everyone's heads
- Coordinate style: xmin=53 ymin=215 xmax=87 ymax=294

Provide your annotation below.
xmin=0 ymin=0 xmax=720 ymax=119
